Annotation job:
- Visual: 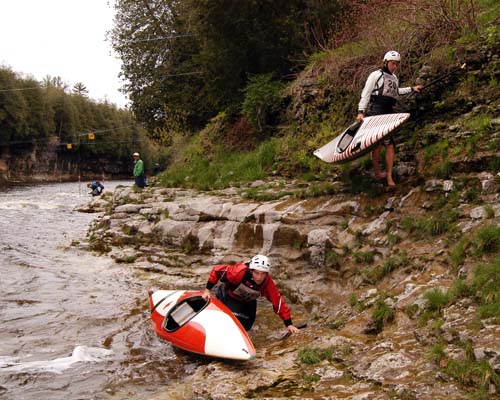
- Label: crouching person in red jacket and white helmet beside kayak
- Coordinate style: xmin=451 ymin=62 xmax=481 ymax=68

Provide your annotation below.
xmin=202 ymin=254 xmax=299 ymax=333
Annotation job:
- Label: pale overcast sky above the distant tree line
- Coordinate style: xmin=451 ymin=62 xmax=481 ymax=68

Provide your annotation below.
xmin=0 ymin=0 xmax=127 ymax=107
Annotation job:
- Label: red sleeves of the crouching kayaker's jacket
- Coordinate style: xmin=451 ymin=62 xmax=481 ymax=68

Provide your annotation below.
xmin=207 ymin=263 xmax=292 ymax=326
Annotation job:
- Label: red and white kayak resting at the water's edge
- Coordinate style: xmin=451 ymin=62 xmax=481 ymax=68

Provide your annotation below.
xmin=148 ymin=289 xmax=255 ymax=361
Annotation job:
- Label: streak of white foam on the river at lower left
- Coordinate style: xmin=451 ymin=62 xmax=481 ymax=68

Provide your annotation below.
xmin=0 ymin=346 xmax=113 ymax=374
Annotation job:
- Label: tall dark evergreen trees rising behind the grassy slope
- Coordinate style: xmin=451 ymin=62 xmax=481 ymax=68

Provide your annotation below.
xmin=110 ymin=0 xmax=348 ymax=131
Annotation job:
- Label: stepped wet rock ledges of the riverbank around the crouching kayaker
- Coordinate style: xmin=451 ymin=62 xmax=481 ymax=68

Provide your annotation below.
xmin=81 ymin=172 xmax=500 ymax=399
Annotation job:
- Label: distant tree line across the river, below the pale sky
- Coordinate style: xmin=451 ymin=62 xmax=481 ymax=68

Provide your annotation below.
xmin=0 ymin=67 xmax=153 ymax=173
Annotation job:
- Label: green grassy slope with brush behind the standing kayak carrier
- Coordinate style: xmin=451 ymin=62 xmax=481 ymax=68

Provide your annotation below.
xmin=162 ymin=0 xmax=500 ymax=190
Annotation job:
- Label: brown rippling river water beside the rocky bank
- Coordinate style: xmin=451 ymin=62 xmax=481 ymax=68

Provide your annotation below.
xmin=0 ymin=182 xmax=206 ymax=400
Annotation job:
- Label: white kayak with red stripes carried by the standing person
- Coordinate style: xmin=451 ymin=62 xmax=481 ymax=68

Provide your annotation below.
xmin=314 ymin=113 xmax=410 ymax=163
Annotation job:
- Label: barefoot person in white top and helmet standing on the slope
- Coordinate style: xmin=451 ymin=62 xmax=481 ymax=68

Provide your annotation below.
xmin=356 ymin=51 xmax=422 ymax=187
